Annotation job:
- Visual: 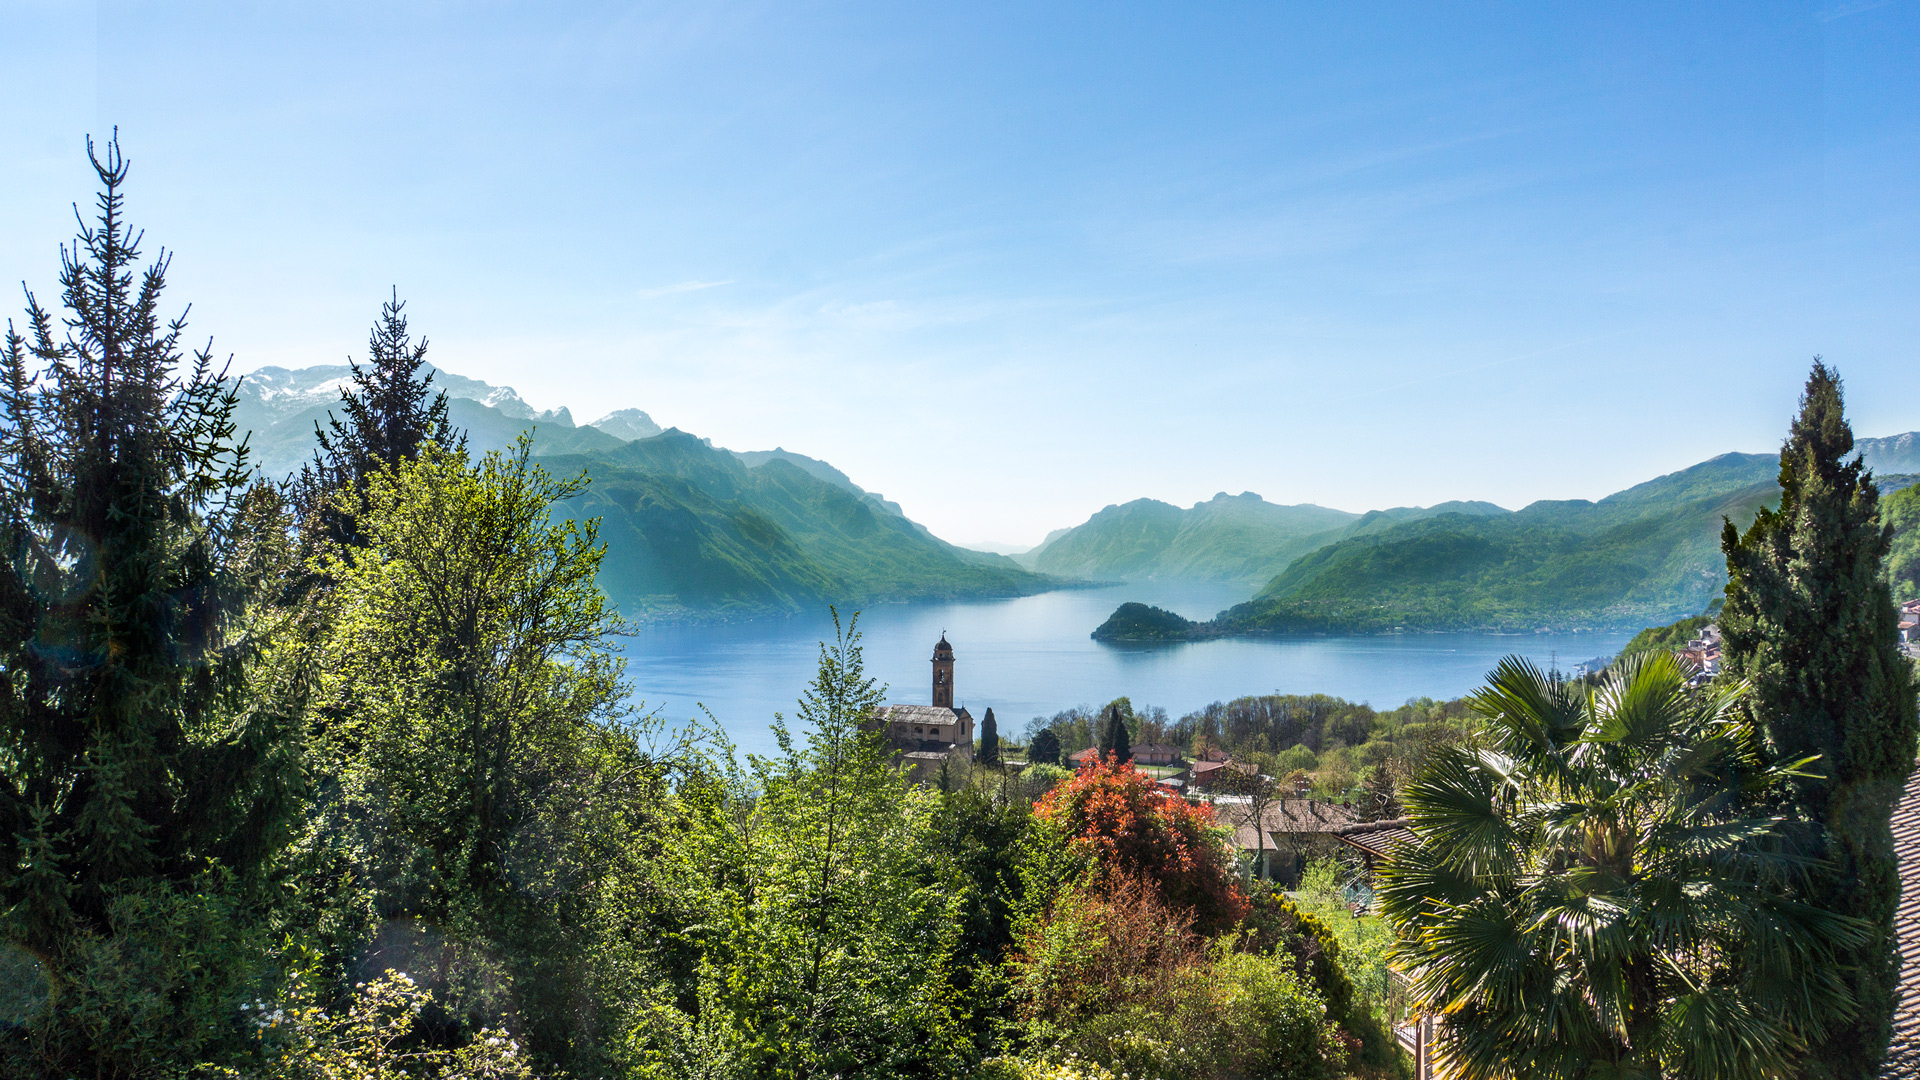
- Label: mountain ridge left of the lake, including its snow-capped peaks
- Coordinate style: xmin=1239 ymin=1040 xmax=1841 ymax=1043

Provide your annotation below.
xmin=236 ymin=365 xmax=1060 ymax=617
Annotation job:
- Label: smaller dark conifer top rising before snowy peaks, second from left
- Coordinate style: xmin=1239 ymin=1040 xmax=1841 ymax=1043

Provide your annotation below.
xmin=294 ymin=288 xmax=467 ymax=550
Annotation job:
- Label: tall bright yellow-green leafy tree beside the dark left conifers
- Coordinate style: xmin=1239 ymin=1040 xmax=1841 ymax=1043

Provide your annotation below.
xmin=305 ymin=436 xmax=664 ymax=1072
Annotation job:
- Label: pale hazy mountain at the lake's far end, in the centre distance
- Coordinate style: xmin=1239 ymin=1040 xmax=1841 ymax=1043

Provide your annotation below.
xmin=1021 ymin=492 xmax=1357 ymax=584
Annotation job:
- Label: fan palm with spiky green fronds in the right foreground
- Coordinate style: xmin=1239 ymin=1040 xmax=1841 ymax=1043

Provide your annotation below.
xmin=1380 ymin=653 xmax=1860 ymax=1080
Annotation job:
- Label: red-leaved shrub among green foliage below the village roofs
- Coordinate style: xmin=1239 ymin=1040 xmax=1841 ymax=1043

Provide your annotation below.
xmin=1033 ymin=757 xmax=1246 ymax=934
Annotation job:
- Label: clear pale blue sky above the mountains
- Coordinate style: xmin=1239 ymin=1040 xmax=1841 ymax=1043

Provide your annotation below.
xmin=0 ymin=0 xmax=1920 ymax=544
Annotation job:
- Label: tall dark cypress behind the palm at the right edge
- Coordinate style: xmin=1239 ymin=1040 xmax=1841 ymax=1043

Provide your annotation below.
xmin=1720 ymin=357 xmax=1916 ymax=1078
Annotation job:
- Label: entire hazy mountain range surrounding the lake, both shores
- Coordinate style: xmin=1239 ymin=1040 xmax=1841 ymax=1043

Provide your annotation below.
xmin=238 ymin=365 xmax=1920 ymax=638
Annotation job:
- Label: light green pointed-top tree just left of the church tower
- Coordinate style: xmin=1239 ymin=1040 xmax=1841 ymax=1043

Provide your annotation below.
xmin=676 ymin=613 xmax=968 ymax=1078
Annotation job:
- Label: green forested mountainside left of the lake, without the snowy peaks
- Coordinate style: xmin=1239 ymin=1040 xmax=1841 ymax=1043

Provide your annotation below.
xmin=545 ymin=430 xmax=1048 ymax=615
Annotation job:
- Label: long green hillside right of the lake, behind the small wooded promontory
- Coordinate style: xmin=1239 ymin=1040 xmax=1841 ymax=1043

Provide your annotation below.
xmin=1208 ymin=454 xmax=1778 ymax=634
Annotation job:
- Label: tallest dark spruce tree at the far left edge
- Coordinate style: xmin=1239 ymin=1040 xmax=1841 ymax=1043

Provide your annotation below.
xmin=0 ymin=136 xmax=300 ymax=1076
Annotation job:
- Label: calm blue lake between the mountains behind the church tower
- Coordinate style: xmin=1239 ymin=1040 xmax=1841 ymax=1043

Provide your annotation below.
xmin=626 ymin=584 xmax=1628 ymax=753
